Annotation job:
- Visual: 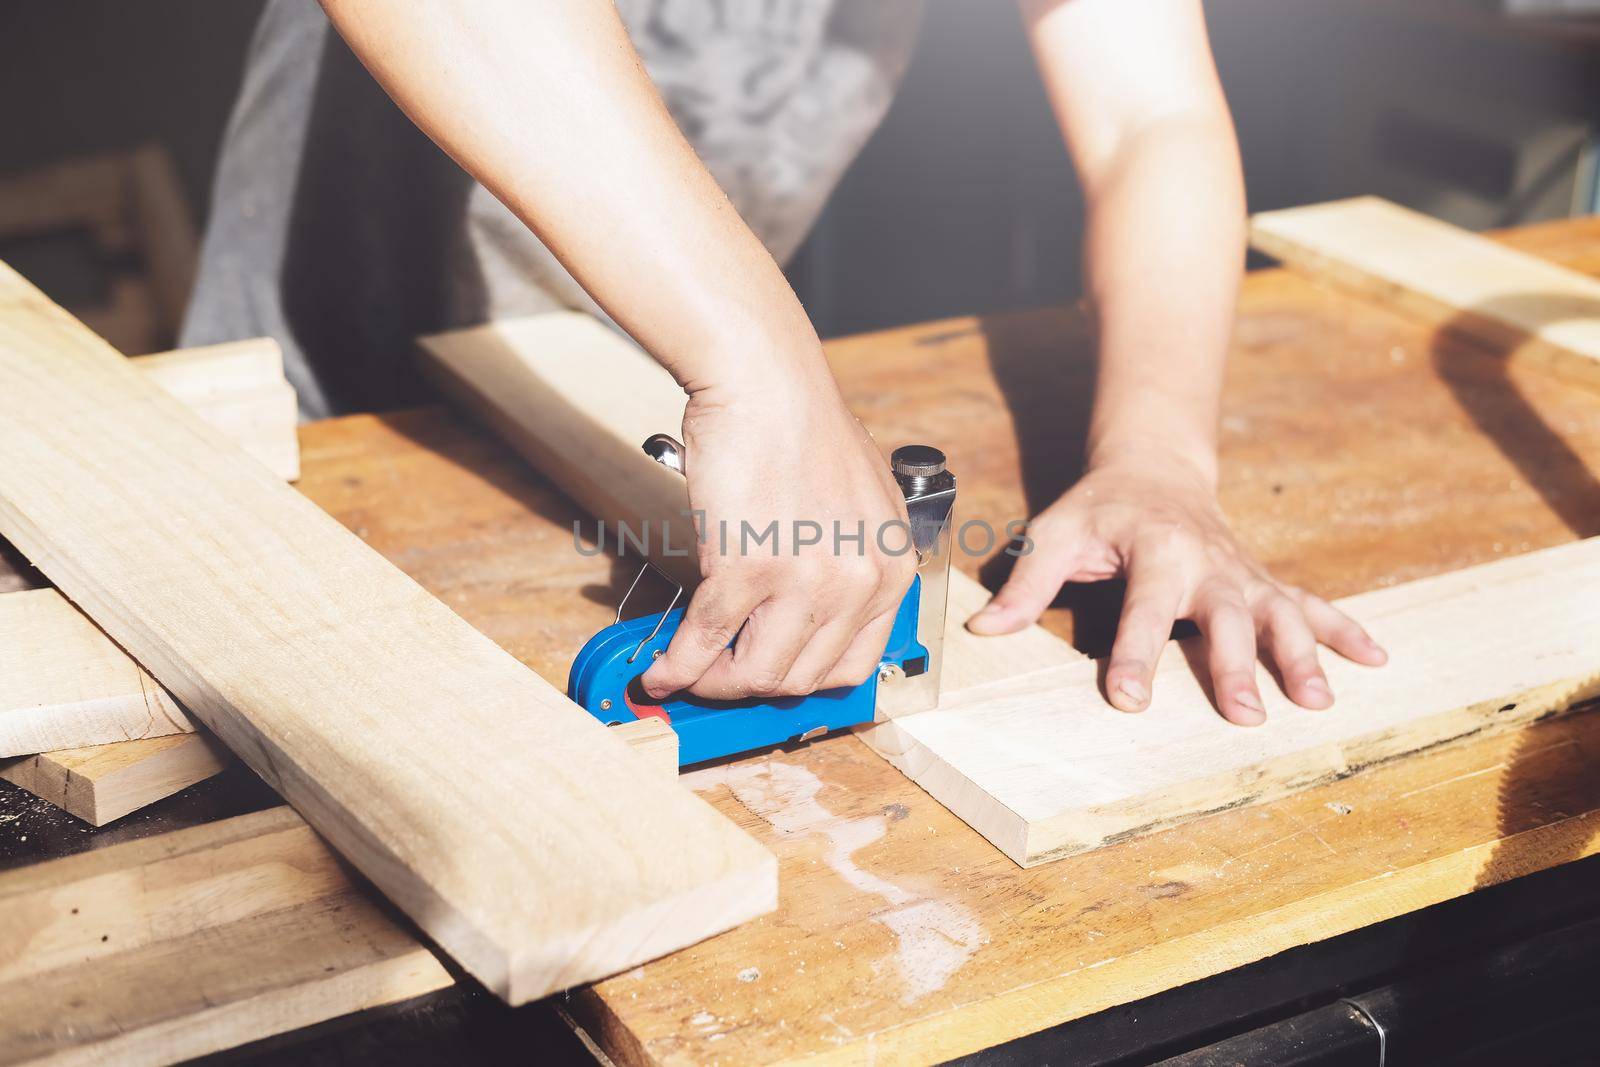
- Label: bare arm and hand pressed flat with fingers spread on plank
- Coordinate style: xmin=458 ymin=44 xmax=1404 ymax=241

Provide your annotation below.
xmin=971 ymin=0 xmax=1384 ymax=725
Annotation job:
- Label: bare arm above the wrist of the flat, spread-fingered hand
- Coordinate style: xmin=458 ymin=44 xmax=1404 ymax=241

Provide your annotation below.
xmin=1021 ymin=0 xmax=1245 ymax=482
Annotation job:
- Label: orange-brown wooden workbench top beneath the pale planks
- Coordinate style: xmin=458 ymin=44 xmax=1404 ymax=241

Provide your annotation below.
xmin=0 ymin=222 xmax=1600 ymax=1064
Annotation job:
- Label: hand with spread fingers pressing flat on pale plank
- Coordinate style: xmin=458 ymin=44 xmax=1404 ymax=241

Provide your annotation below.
xmin=966 ymin=441 xmax=1387 ymax=726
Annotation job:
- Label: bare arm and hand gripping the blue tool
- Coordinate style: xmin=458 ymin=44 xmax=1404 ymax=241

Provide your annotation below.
xmin=323 ymin=0 xmax=914 ymax=697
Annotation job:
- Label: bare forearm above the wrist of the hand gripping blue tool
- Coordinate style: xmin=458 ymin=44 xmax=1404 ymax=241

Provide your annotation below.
xmin=323 ymin=0 xmax=826 ymax=392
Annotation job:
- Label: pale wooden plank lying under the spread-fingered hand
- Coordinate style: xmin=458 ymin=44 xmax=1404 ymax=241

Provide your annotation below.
xmin=874 ymin=539 xmax=1600 ymax=865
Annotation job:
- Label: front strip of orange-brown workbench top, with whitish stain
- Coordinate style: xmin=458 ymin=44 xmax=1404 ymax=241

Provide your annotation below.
xmin=573 ymin=713 xmax=1600 ymax=1065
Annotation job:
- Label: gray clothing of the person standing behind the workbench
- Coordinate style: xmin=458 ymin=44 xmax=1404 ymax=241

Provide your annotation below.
xmin=179 ymin=0 xmax=922 ymax=418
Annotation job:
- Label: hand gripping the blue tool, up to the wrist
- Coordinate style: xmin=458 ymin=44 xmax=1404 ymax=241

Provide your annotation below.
xmin=643 ymin=370 xmax=917 ymax=699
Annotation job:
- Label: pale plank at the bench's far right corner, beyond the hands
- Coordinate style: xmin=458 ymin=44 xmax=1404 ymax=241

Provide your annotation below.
xmin=1250 ymin=197 xmax=1600 ymax=386
